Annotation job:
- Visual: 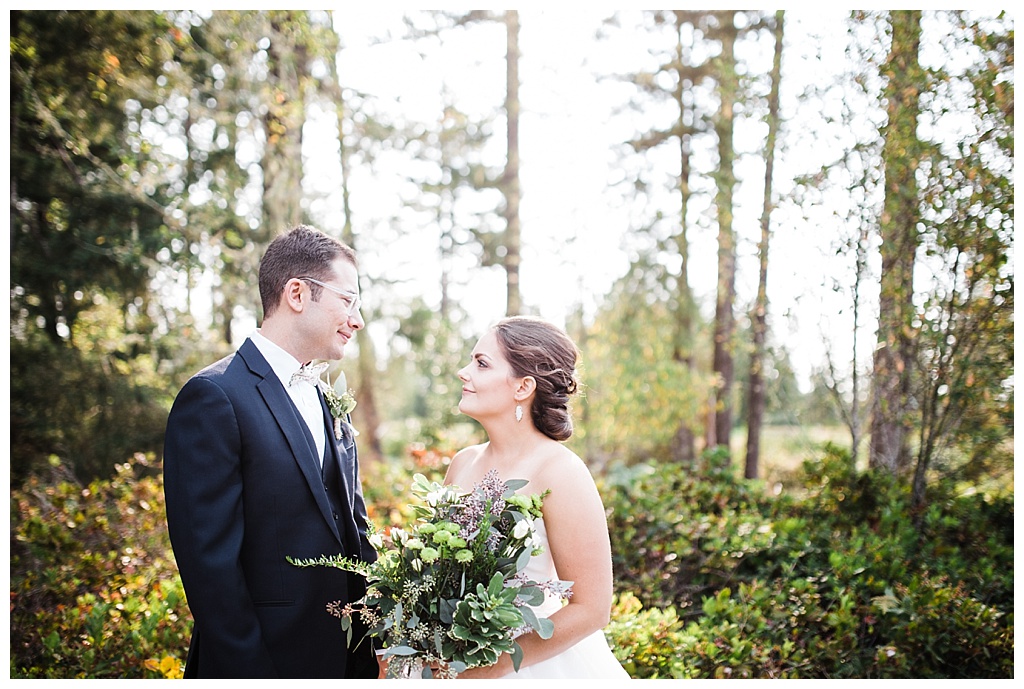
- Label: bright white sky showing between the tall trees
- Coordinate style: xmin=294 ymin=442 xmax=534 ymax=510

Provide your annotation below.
xmin=296 ymin=6 xmax=871 ymax=389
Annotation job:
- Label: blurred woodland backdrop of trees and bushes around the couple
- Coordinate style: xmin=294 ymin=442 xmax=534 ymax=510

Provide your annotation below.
xmin=9 ymin=10 xmax=1014 ymax=678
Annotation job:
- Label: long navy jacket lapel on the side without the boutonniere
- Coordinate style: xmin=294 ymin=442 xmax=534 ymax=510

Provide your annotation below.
xmin=239 ymin=340 xmax=344 ymax=543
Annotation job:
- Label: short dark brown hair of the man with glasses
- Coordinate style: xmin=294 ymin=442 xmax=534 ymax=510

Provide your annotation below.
xmin=259 ymin=225 xmax=355 ymax=318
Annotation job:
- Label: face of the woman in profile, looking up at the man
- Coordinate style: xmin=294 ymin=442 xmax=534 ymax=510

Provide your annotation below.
xmin=459 ymin=331 xmax=517 ymax=421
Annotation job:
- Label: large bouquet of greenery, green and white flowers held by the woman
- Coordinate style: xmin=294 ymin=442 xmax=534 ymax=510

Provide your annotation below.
xmin=292 ymin=471 xmax=571 ymax=678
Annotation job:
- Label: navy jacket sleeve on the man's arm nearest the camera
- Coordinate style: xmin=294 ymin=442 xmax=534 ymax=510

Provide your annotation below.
xmin=164 ymin=378 xmax=278 ymax=677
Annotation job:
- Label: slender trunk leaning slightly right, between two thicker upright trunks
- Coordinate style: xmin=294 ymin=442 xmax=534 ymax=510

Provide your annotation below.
xmin=743 ymin=10 xmax=785 ymax=478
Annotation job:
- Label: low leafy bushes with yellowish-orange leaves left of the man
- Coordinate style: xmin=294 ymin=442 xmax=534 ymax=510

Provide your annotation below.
xmin=10 ymin=456 xmax=191 ymax=678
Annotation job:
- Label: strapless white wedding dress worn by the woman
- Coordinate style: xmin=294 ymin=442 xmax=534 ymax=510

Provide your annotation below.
xmin=502 ymin=519 xmax=630 ymax=680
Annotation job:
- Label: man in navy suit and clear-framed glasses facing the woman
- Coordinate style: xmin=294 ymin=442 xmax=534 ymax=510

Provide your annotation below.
xmin=164 ymin=225 xmax=378 ymax=678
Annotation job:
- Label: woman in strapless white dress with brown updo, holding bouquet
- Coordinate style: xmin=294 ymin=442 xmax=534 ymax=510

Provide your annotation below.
xmin=444 ymin=316 xmax=629 ymax=679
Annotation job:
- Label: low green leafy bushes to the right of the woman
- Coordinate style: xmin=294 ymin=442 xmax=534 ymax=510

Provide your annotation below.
xmin=604 ymin=447 xmax=1014 ymax=678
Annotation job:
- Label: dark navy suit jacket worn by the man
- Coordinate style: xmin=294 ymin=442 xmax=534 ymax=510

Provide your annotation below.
xmin=164 ymin=340 xmax=377 ymax=678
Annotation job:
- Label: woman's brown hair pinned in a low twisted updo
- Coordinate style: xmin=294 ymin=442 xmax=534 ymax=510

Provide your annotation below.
xmin=495 ymin=316 xmax=580 ymax=440
